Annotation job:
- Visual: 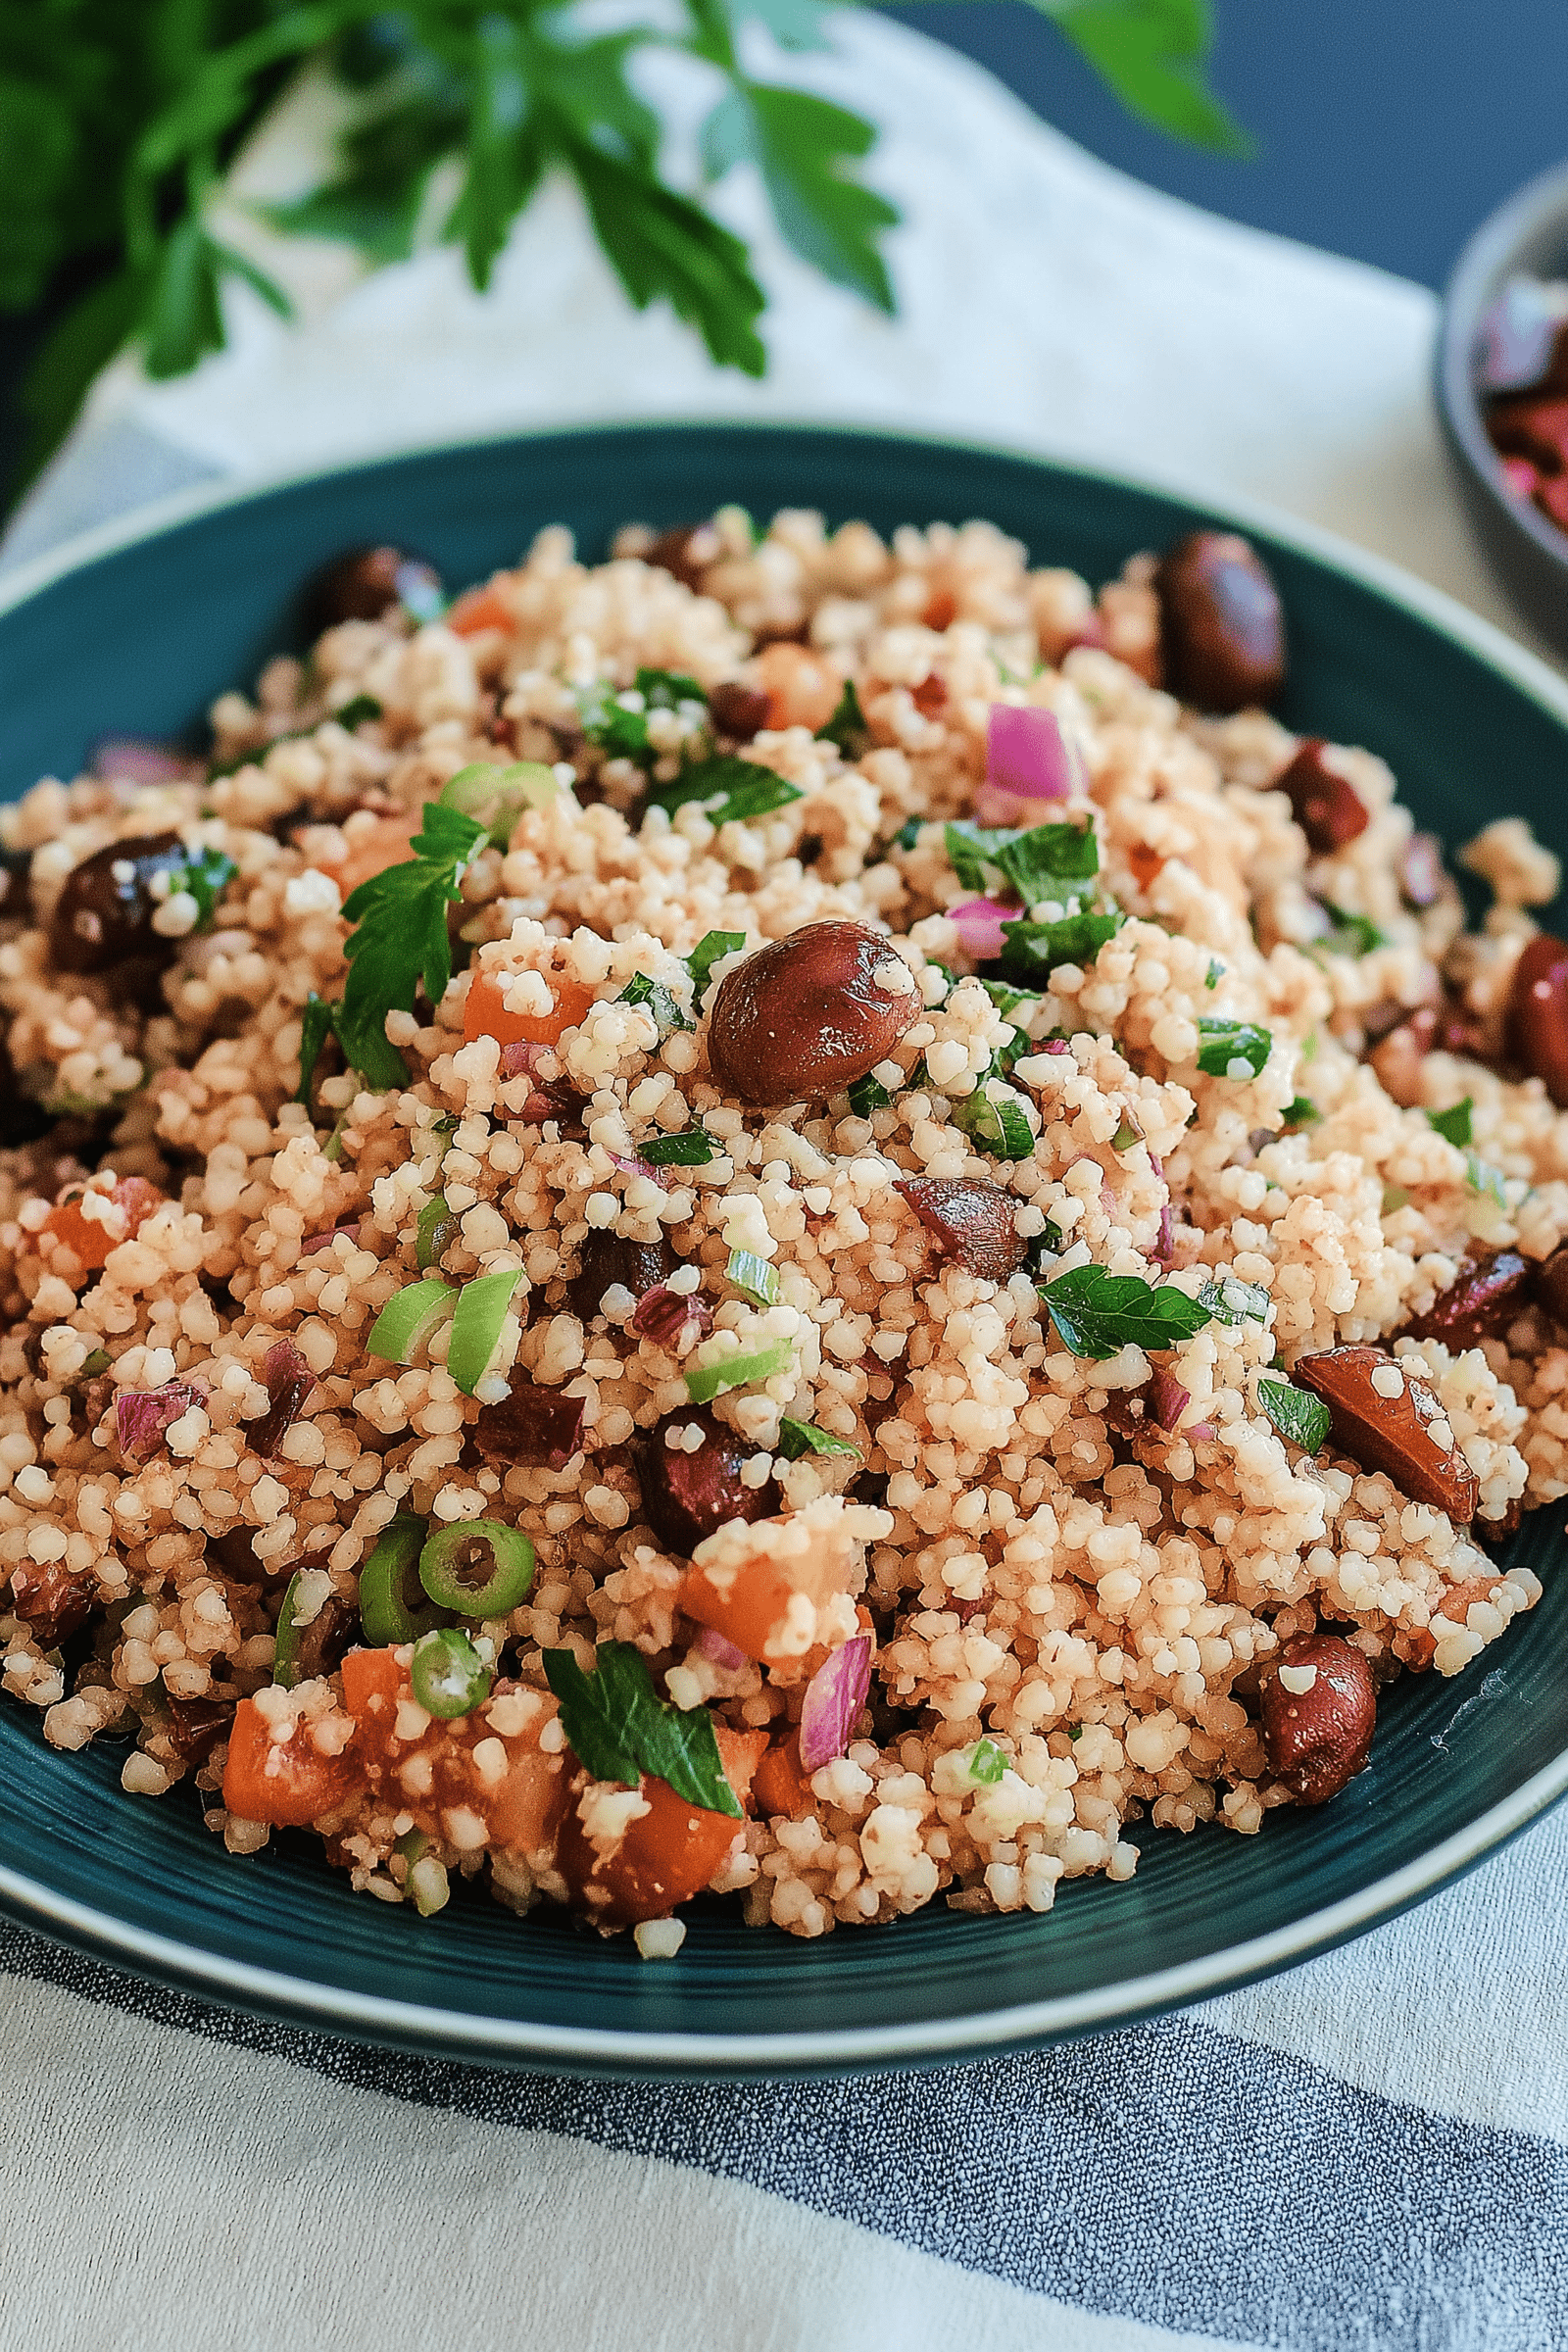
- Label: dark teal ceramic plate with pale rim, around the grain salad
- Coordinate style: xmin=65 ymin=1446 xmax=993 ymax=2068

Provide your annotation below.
xmin=0 ymin=425 xmax=1568 ymax=2075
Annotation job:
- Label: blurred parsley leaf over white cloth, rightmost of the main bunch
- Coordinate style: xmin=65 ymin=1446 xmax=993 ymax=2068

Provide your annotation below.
xmin=703 ymin=77 xmax=898 ymax=313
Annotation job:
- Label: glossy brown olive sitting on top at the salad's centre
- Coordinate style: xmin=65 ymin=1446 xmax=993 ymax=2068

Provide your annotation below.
xmin=708 ymin=922 xmax=921 ymax=1103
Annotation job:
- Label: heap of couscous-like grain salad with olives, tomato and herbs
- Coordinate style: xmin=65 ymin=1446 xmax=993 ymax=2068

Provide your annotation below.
xmin=0 ymin=508 xmax=1568 ymax=1954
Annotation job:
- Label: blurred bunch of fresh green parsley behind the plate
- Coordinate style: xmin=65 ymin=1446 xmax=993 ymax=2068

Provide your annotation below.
xmin=0 ymin=0 xmax=1246 ymax=491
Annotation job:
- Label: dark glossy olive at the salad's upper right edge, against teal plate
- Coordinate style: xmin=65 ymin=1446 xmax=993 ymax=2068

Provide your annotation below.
xmin=1154 ymin=531 xmax=1286 ymax=710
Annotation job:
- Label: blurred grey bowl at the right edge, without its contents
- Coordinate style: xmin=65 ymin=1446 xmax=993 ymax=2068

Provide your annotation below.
xmin=1437 ymin=165 xmax=1568 ymax=654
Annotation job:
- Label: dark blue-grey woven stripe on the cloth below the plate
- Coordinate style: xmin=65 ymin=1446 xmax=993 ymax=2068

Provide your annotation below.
xmin=0 ymin=1924 xmax=1568 ymax=2352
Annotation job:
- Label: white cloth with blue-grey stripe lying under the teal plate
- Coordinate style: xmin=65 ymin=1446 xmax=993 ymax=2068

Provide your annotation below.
xmin=0 ymin=22 xmax=1568 ymax=2352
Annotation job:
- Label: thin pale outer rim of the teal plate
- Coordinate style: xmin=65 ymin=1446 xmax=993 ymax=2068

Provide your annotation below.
xmin=0 ymin=416 xmax=1568 ymax=2077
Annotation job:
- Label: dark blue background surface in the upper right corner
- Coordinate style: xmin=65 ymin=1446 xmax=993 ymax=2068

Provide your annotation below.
xmin=888 ymin=0 xmax=1568 ymax=287
